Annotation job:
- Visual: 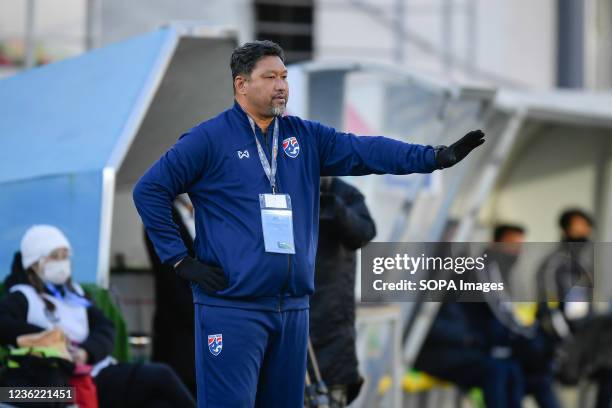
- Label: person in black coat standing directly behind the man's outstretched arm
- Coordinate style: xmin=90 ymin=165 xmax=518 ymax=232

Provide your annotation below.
xmin=310 ymin=177 xmax=376 ymax=407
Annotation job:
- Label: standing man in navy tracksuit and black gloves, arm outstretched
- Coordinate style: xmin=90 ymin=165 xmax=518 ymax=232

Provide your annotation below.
xmin=134 ymin=41 xmax=484 ymax=408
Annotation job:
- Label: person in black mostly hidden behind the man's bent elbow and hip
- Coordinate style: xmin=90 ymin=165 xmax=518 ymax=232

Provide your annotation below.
xmin=145 ymin=196 xmax=196 ymax=396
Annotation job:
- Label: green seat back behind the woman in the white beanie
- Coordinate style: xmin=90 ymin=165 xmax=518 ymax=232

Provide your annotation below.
xmin=0 ymin=283 xmax=130 ymax=363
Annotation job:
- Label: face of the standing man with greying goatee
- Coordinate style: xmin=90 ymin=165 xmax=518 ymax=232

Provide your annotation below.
xmin=235 ymin=56 xmax=289 ymax=117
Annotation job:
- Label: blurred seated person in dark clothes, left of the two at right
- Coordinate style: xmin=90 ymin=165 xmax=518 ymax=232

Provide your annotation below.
xmin=415 ymin=225 xmax=529 ymax=407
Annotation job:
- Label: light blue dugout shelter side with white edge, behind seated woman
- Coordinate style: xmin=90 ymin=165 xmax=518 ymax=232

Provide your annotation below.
xmin=0 ymin=28 xmax=204 ymax=283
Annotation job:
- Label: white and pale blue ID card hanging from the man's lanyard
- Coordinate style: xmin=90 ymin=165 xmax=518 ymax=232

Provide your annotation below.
xmin=259 ymin=194 xmax=295 ymax=254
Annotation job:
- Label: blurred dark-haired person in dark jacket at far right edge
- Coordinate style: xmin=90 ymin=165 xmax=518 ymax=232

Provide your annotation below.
xmin=537 ymin=208 xmax=612 ymax=408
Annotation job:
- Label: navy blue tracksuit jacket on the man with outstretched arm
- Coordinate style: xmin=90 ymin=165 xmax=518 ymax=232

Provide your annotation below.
xmin=133 ymin=103 xmax=436 ymax=311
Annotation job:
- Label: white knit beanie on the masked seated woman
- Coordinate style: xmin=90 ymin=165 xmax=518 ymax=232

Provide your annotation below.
xmin=21 ymin=225 xmax=71 ymax=269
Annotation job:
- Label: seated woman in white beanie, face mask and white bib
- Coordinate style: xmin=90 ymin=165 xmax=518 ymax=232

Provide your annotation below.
xmin=0 ymin=225 xmax=195 ymax=407
